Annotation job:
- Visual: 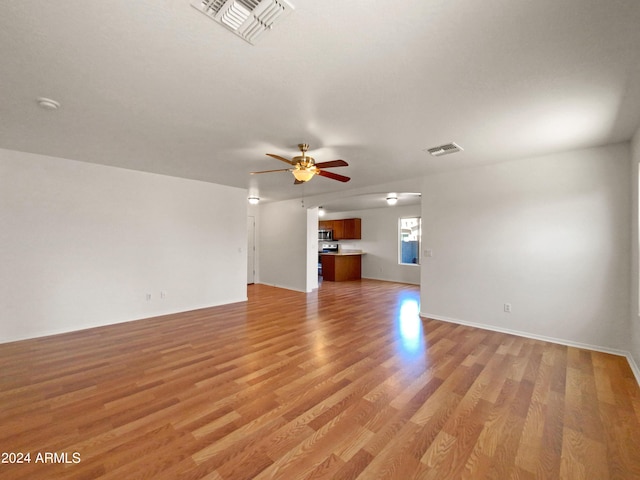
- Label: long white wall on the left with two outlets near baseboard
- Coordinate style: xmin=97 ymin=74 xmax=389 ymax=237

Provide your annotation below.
xmin=0 ymin=150 xmax=247 ymax=342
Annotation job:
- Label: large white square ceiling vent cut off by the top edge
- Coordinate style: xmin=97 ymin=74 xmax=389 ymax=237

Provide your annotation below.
xmin=191 ymin=0 xmax=293 ymax=45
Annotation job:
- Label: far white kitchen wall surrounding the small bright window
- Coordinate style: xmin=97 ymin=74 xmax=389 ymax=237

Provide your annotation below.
xmin=324 ymin=205 xmax=424 ymax=285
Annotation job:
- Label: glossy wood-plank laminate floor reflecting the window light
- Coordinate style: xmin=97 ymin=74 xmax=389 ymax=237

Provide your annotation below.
xmin=0 ymin=280 xmax=640 ymax=480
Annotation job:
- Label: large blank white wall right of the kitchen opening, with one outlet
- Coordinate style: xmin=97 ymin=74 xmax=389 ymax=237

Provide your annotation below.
xmin=421 ymin=143 xmax=631 ymax=350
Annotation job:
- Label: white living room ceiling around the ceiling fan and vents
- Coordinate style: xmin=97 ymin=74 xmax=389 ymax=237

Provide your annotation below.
xmin=0 ymin=0 xmax=640 ymax=208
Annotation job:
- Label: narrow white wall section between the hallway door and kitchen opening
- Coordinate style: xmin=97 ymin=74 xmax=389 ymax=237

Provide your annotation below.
xmin=258 ymin=200 xmax=317 ymax=292
